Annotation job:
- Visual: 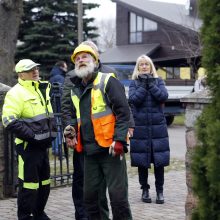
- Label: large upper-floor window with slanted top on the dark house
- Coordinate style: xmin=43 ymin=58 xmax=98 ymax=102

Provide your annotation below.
xmin=129 ymin=12 xmax=157 ymax=44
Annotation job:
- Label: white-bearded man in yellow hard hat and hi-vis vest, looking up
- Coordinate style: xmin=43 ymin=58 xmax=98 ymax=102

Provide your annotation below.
xmin=62 ymin=45 xmax=132 ymax=220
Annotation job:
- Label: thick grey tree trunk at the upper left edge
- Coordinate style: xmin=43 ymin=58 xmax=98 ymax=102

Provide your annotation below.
xmin=0 ymin=0 xmax=23 ymax=86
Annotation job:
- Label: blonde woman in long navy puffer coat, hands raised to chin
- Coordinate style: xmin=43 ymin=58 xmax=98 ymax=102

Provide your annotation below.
xmin=129 ymin=55 xmax=170 ymax=204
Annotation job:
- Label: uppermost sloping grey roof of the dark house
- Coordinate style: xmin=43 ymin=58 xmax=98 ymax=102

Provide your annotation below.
xmin=112 ymin=0 xmax=202 ymax=31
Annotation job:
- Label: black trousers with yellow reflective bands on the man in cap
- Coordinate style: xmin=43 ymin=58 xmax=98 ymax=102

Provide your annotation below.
xmin=16 ymin=144 xmax=50 ymax=220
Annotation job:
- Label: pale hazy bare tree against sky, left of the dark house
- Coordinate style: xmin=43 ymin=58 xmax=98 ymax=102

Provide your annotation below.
xmin=97 ymin=19 xmax=116 ymax=52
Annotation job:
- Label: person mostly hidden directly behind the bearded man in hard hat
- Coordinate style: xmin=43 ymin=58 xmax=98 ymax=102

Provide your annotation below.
xmin=61 ymin=41 xmax=112 ymax=220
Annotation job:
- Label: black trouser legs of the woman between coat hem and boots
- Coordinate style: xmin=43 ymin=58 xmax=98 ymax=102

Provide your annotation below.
xmin=138 ymin=167 xmax=164 ymax=192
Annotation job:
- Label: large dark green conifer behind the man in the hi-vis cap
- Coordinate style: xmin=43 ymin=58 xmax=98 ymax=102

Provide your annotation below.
xmin=16 ymin=0 xmax=98 ymax=78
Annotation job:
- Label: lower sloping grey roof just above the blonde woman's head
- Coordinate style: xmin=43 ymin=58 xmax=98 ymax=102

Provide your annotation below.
xmin=100 ymin=44 xmax=160 ymax=63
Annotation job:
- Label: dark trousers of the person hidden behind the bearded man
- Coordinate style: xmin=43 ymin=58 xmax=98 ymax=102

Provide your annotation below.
xmin=72 ymin=151 xmax=109 ymax=220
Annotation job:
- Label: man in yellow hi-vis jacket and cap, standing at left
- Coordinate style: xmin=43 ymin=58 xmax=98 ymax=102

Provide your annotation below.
xmin=2 ymin=59 xmax=56 ymax=220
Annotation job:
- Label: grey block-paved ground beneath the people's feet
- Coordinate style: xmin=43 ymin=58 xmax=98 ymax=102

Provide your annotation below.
xmin=0 ymin=170 xmax=186 ymax=220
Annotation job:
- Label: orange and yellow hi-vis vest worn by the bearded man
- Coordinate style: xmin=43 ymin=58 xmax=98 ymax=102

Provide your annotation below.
xmin=71 ymin=72 xmax=115 ymax=152
